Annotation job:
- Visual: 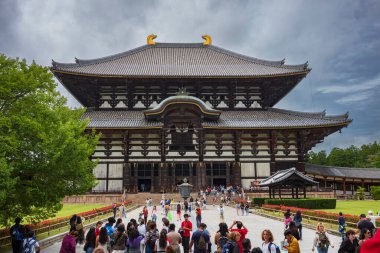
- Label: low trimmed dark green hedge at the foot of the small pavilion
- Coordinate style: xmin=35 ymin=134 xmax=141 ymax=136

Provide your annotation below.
xmin=264 ymin=199 xmax=336 ymax=209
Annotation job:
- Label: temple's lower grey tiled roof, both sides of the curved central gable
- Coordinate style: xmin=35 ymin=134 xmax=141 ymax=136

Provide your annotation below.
xmin=83 ymin=108 xmax=351 ymax=129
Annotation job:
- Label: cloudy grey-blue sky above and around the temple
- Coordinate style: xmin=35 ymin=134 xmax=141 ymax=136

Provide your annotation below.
xmin=0 ymin=0 xmax=380 ymax=151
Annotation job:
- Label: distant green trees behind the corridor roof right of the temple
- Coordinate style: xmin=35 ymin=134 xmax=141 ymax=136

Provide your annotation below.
xmin=308 ymin=141 xmax=380 ymax=168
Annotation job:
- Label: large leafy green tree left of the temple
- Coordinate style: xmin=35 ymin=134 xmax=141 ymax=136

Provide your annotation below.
xmin=0 ymin=54 xmax=99 ymax=225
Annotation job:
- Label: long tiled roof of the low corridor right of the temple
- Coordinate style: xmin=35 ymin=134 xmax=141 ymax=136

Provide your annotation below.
xmin=305 ymin=163 xmax=380 ymax=180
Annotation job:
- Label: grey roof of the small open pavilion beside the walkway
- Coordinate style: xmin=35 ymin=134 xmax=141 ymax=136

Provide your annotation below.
xmin=260 ymin=168 xmax=318 ymax=186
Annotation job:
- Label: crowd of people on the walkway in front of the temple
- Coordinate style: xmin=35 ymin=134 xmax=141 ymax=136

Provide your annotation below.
xmin=10 ymin=195 xmax=380 ymax=253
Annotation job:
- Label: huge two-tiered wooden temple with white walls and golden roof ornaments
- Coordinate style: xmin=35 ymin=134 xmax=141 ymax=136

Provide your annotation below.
xmin=51 ymin=35 xmax=351 ymax=192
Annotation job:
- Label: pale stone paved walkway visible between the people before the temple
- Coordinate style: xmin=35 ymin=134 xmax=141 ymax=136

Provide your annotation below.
xmin=41 ymin=205 xmax=341 ymax=253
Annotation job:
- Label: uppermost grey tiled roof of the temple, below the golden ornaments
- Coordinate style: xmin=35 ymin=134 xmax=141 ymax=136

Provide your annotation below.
xmin=52 ymin=43 xmax=310 ymax=77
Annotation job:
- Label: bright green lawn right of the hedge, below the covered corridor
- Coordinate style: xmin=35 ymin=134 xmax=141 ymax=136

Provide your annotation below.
xmin=321 ymin=200 xmax=380 ymax=215
